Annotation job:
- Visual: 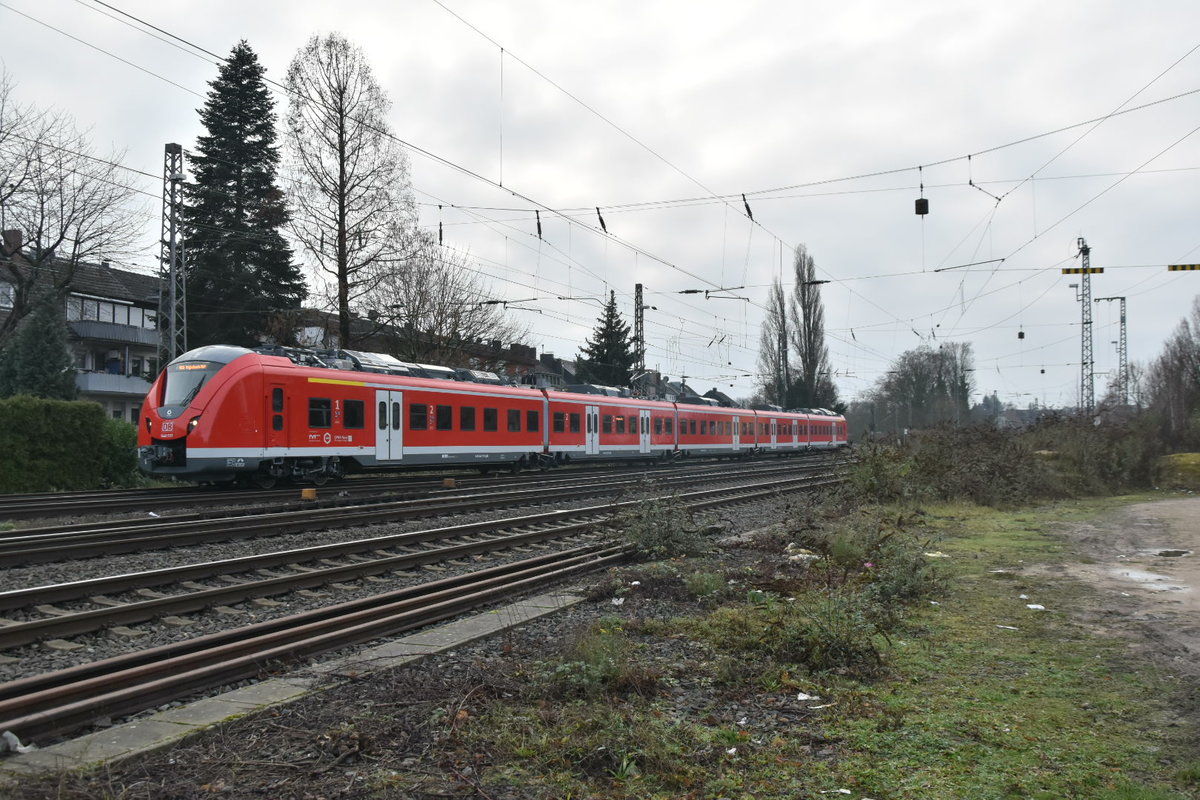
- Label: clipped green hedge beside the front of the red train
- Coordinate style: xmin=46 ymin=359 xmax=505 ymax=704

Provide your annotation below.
xmin=0 ymin=396 xmax=139 ymax=492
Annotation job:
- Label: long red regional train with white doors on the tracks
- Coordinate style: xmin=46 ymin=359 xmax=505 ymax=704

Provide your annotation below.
xmin=138 ymin=345 xmax=847 ymax=486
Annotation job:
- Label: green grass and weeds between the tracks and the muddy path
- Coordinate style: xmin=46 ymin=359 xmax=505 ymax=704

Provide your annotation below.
xmin=436 ymin=498 xmax=1200 ymax=800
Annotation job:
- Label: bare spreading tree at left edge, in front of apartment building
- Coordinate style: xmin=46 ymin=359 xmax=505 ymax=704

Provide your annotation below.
xmin=0 ymin=74 xmax=145 ymax=343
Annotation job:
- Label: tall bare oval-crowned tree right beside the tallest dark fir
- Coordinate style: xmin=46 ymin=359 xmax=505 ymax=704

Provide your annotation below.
xmin=286 ymin=34 xmax=415 ymax=347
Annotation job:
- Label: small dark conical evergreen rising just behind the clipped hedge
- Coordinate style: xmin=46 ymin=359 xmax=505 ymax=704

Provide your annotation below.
xmin=0 ymin=291 xmax=79 ymax=399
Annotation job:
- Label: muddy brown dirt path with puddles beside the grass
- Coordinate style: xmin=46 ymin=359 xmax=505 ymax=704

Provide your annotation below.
xmin=1032 ymin=498 xmax=1200 ymax=678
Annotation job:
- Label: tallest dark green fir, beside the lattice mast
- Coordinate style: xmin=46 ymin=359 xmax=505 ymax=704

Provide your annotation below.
xmin=184 ymin=41 xmax=308 ymax=347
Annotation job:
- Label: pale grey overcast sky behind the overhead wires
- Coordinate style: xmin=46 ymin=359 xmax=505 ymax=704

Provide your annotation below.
xmin=0 ymin=0 xmax=1200 ymax=407
